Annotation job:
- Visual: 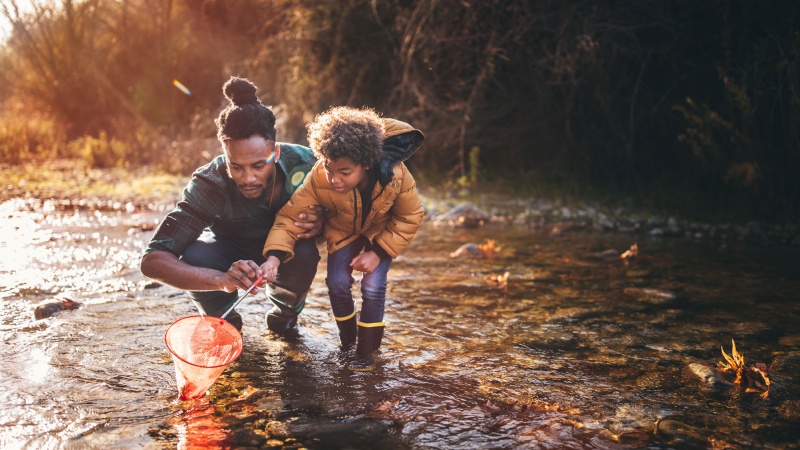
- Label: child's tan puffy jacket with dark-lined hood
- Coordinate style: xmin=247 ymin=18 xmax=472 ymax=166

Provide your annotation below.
xmin=263 ymin=119 xmax=425 ymax=262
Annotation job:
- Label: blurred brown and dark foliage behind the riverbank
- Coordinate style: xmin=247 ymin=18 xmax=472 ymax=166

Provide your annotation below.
xmin=0 ymin=0 xmax=800 ymax=221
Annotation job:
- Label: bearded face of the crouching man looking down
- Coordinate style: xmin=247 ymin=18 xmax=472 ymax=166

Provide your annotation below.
xmin=225 ymin=135 xmax=280 ymax=198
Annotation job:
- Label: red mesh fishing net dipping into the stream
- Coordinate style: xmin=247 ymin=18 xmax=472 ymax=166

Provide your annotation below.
xmin=164 ymin=316 xmax=242 ymax=400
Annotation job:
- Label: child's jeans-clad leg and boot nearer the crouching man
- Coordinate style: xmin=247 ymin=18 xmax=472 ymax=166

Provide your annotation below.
xmin=325 ymin=239 xmax=364 ymax=350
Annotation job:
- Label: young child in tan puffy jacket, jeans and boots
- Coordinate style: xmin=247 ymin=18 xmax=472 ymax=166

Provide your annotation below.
xmin=261 ymin=107 xmax=425 ymax=371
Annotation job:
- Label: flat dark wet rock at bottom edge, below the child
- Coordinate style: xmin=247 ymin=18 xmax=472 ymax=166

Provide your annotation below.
xmin=290 ymin=420 xmax=387 ymax=448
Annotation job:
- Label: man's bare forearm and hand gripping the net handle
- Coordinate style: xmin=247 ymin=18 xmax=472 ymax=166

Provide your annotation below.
xmin=140 ymin=250 xmax=262 ymax=294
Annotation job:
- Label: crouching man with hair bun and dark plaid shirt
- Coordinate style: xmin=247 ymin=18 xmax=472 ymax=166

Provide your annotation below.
xmin=141 ymin=77 xmax=322 ymax=334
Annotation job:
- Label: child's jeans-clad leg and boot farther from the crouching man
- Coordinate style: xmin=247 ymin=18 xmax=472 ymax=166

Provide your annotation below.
xmin=350 ymin=258 xmax=392 ymax=371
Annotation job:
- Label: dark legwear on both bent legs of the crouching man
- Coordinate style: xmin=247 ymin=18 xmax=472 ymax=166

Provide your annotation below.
xmin=181 ymin=231 xmax=320 ymax=331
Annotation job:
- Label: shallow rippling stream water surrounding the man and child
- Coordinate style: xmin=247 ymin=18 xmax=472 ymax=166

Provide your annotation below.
xmin=0 ymin=201 xmax=800 ymax=449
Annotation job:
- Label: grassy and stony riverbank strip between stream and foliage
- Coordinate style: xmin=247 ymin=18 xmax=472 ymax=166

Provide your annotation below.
xmin=0 ymin=160 xmax=800 ymax=247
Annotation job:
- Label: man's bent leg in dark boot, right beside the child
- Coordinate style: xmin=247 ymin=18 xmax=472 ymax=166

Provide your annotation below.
xmin=266 ymin=238 xmax=320 ymax=335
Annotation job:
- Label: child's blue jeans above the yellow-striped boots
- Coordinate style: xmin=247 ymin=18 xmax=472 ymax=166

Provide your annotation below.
xmin=325 ymin=237 xmax=392 ymax=323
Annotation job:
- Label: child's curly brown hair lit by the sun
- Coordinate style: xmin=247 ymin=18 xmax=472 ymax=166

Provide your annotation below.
xmin=306 ymin=106 xmax=384 ymax=167
